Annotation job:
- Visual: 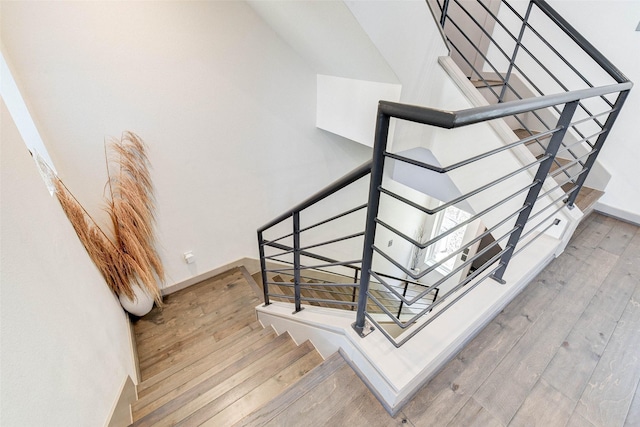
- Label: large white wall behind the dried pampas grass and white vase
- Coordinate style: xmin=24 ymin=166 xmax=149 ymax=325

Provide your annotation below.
xmin=1 ymin=1 xmax=370 ymax=285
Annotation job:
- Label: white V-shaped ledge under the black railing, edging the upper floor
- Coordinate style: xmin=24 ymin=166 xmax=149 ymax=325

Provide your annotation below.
xmin=256 ymin=235 xmax=563 ymax=415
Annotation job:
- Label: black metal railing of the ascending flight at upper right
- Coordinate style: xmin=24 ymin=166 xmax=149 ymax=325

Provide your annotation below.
xmin=436 ymin=0 xmax=628 ymax=206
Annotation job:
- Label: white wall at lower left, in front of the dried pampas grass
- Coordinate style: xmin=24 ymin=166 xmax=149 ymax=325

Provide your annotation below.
xmin=0 ymin=101 xmax=135 ymax=426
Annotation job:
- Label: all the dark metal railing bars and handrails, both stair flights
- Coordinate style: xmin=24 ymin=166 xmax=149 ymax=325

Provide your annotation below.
xmin=258 ymin=0 xmax=633 ymax=346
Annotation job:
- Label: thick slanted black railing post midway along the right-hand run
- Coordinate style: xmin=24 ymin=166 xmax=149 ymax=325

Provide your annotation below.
xmin=491 ymin=101 xmax=578 ymax=284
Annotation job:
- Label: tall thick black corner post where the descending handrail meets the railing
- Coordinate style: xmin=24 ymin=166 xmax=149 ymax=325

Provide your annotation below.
xmin=351 ymin=105 xmax=391 ymax=336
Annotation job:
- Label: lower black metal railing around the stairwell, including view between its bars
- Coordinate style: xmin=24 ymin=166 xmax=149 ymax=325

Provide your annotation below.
xmin=258 ymin=0 xmax=632 ymax=346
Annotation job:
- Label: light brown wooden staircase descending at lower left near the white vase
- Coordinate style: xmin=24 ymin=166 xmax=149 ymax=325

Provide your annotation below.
xmin=132 ymin=269 xmax=336 ymax=426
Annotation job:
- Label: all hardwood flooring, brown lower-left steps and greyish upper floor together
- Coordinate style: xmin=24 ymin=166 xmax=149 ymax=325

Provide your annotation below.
xmin=127 ymin=214 xmax=640 ymax=427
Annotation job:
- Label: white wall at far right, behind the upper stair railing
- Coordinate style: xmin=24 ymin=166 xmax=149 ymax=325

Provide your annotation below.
xmin=489 ymin=0 xmax=640 ymax=223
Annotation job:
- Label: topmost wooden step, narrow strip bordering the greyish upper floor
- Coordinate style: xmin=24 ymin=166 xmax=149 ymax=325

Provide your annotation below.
xmin=234 ymin=352 xmax=346 ymax=427
